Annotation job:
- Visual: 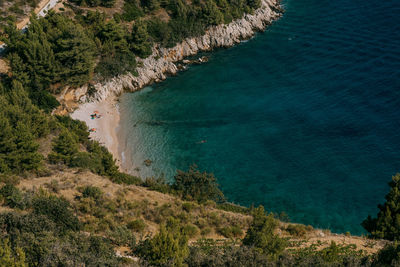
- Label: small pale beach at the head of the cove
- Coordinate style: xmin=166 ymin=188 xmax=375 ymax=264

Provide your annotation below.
xmin=71 ymin=97 xmax=121 ymax=168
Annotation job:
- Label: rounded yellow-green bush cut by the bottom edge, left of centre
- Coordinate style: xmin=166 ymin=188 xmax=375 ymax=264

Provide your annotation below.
xmin=137 ymin=225 xmax=189 ymax=266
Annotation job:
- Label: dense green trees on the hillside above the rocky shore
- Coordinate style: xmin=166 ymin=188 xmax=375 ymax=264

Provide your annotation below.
xmin=1 ymin=0 xmax=266 ymax=112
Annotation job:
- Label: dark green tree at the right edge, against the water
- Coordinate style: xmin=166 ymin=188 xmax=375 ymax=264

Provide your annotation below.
xmin=362 ymin=174 xmax=400 ymax=240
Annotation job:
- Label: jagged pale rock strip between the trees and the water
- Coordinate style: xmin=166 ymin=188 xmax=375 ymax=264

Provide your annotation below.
xmin=75 ymin=0 xmax=281 ymax=102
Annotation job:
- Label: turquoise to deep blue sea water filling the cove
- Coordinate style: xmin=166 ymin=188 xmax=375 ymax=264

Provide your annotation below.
xmin=121 ymin=0 xmax=400 ymax=234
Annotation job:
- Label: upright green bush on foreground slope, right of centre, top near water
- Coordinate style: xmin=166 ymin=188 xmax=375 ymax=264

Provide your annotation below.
xmin=243 ymin=206 xmax=287 ymax=258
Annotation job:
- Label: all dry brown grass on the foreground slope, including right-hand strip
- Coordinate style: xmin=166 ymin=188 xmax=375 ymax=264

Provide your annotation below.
xmin=14 ymin=169 xmax=386 ymax=254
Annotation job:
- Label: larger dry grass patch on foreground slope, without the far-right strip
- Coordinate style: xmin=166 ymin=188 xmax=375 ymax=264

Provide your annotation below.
xmin=18 ymin=169 xmax=251 ymax=240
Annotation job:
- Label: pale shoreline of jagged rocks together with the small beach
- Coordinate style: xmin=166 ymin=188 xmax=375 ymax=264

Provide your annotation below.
xmin=69 ymin=0 xmax=281 ymax=174
